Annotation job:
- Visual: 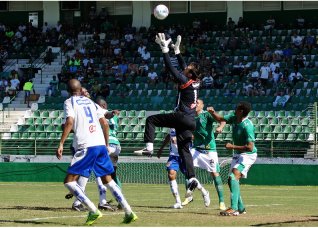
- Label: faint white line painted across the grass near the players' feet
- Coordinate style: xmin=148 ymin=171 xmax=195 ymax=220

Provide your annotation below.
xmin=15 ymin=204 xmax=283 ymax=221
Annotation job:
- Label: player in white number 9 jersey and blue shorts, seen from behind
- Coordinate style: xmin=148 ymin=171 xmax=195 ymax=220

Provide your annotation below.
xmin=56 ymin=79 xmax=138 ymax=225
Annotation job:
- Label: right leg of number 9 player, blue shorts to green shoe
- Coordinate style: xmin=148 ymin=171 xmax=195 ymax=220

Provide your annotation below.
xmin=94 ymin=146 xmax=138 ymax=223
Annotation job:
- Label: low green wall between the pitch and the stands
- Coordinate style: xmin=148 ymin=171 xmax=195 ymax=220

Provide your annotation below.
xmin=0 ymin=162 xmax=318 ymax=185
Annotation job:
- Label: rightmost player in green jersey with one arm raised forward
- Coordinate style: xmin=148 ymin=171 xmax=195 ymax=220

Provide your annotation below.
xmin=208 ymin=101 xmax=257 ymax=216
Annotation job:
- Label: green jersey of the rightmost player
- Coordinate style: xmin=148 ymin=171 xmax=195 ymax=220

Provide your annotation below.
xmin=224 ymin=113 xmax=257 ymax=154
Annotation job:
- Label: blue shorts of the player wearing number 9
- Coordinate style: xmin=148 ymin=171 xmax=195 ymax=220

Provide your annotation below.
xmin=67 ymin=146 xmax=114 ymax=177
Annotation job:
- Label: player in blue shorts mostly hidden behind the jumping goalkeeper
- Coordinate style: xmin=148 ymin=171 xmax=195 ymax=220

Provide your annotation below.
xmin=157 ymin=128 xmax=210 ymax=209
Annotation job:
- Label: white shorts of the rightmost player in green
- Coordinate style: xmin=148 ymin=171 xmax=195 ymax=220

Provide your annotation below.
xmin=230 ymin=153 xmax=257 ymax=178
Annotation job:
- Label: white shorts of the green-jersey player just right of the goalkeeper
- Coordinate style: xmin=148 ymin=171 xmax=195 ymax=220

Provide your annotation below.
xmin=190 ymin=148 xmax=220 ymax=173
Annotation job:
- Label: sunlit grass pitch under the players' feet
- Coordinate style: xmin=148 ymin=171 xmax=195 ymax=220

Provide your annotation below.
xmin=0 ymin=183 xmax=318 ymax=227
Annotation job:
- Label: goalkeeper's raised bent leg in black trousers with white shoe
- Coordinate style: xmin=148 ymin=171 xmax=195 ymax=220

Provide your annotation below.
xmin=134 ymin=113 xmax=180 ymax=156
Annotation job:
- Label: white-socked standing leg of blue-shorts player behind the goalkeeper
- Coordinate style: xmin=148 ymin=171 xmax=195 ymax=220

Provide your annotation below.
xmin=166 ymin=156 xmax=182 ymax=209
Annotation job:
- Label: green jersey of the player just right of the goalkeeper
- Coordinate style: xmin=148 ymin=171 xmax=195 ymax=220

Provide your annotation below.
xmin=193 ymin=111 xmax=216 ymax=152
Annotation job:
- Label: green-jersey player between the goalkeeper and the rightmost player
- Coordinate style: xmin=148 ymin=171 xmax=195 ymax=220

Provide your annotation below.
xmin=182 ymin=99 xmax=226 ymax=210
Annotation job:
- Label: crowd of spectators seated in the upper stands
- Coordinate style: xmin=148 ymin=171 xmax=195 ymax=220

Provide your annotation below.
xmin=0 ymin=10 xmax=317 ymax=109
